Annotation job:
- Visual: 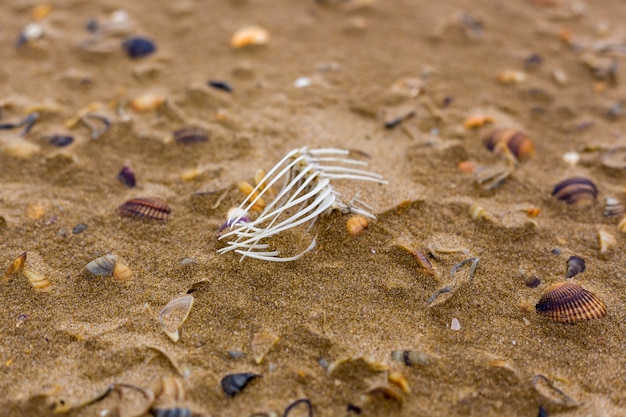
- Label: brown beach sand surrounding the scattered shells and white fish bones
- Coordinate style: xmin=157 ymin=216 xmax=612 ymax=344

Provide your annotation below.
xmin=0 ymin=0 xmax=626 ymax=417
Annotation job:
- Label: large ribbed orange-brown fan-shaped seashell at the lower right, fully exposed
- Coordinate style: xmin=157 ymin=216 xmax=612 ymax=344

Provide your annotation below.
xmin=535 ymin=282 xmax=606 ymax=323
